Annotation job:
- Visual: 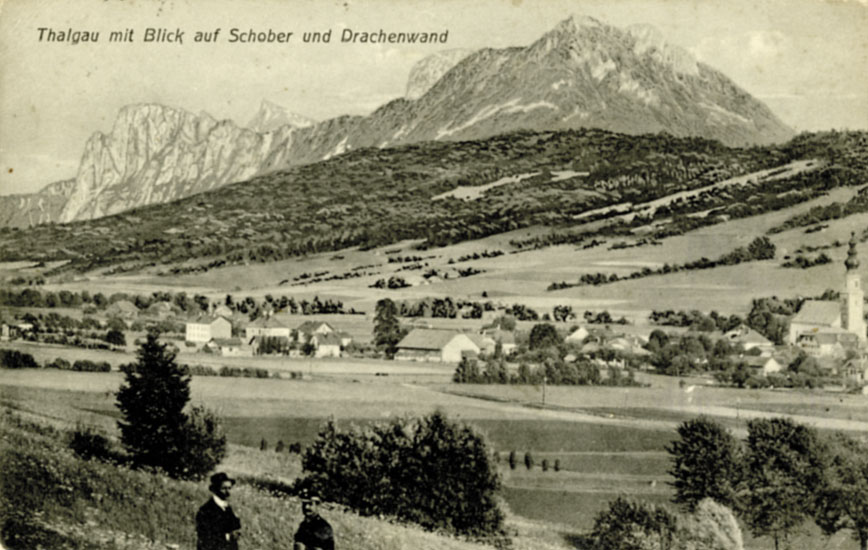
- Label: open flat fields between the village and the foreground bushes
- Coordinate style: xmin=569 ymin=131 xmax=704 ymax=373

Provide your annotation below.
xmin=0 ymin=364 xmax=868 ymax=549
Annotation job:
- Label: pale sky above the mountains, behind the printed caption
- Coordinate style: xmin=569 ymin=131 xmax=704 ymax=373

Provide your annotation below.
xmin=0 ymin=0 xmax=868 ymax=195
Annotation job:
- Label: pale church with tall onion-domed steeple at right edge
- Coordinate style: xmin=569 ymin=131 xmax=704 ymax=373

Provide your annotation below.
xmin=788 ymin=234 xmax=868 ymax=355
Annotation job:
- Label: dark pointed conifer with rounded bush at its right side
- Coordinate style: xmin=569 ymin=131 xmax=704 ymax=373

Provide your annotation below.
xmin=116 ymin=333 xmax=226 ymax=479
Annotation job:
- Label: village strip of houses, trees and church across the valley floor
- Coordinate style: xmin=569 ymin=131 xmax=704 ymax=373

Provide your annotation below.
xmin=0 ymin=240 xmax=868 ymax=391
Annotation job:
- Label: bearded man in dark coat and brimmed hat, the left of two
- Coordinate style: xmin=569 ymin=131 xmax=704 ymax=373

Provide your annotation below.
xmin=196 ymin=472 xmax=241 ymax=550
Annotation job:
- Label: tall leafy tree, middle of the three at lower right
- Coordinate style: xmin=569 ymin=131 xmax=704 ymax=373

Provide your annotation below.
xmin=742 ymin=418 xmax=828 ymax=550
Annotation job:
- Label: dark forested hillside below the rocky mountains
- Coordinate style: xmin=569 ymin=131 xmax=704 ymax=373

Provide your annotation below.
xmin=0 ymin=130 xmax=868 ymax=271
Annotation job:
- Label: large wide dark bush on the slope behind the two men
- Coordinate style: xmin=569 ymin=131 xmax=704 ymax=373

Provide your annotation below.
xmin=296 ymin=412 xmax=503 ymax=536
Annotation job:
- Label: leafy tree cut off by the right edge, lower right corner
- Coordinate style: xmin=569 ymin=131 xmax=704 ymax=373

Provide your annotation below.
xmin=815 ymin=432 xmax=868 ymax=550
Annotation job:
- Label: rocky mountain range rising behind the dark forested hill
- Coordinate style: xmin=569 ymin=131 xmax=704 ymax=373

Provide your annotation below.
xmin=0 ymin=17 xmax=793 ymax=226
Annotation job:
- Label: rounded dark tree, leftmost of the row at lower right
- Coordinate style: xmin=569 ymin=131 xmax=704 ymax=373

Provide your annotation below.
xmin=666 ymin=416 xmax=741 ymax=510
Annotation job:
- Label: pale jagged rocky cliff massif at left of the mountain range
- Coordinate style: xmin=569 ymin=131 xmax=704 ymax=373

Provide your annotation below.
xmin=59 ymin=105 xmax=293 ymax=222
